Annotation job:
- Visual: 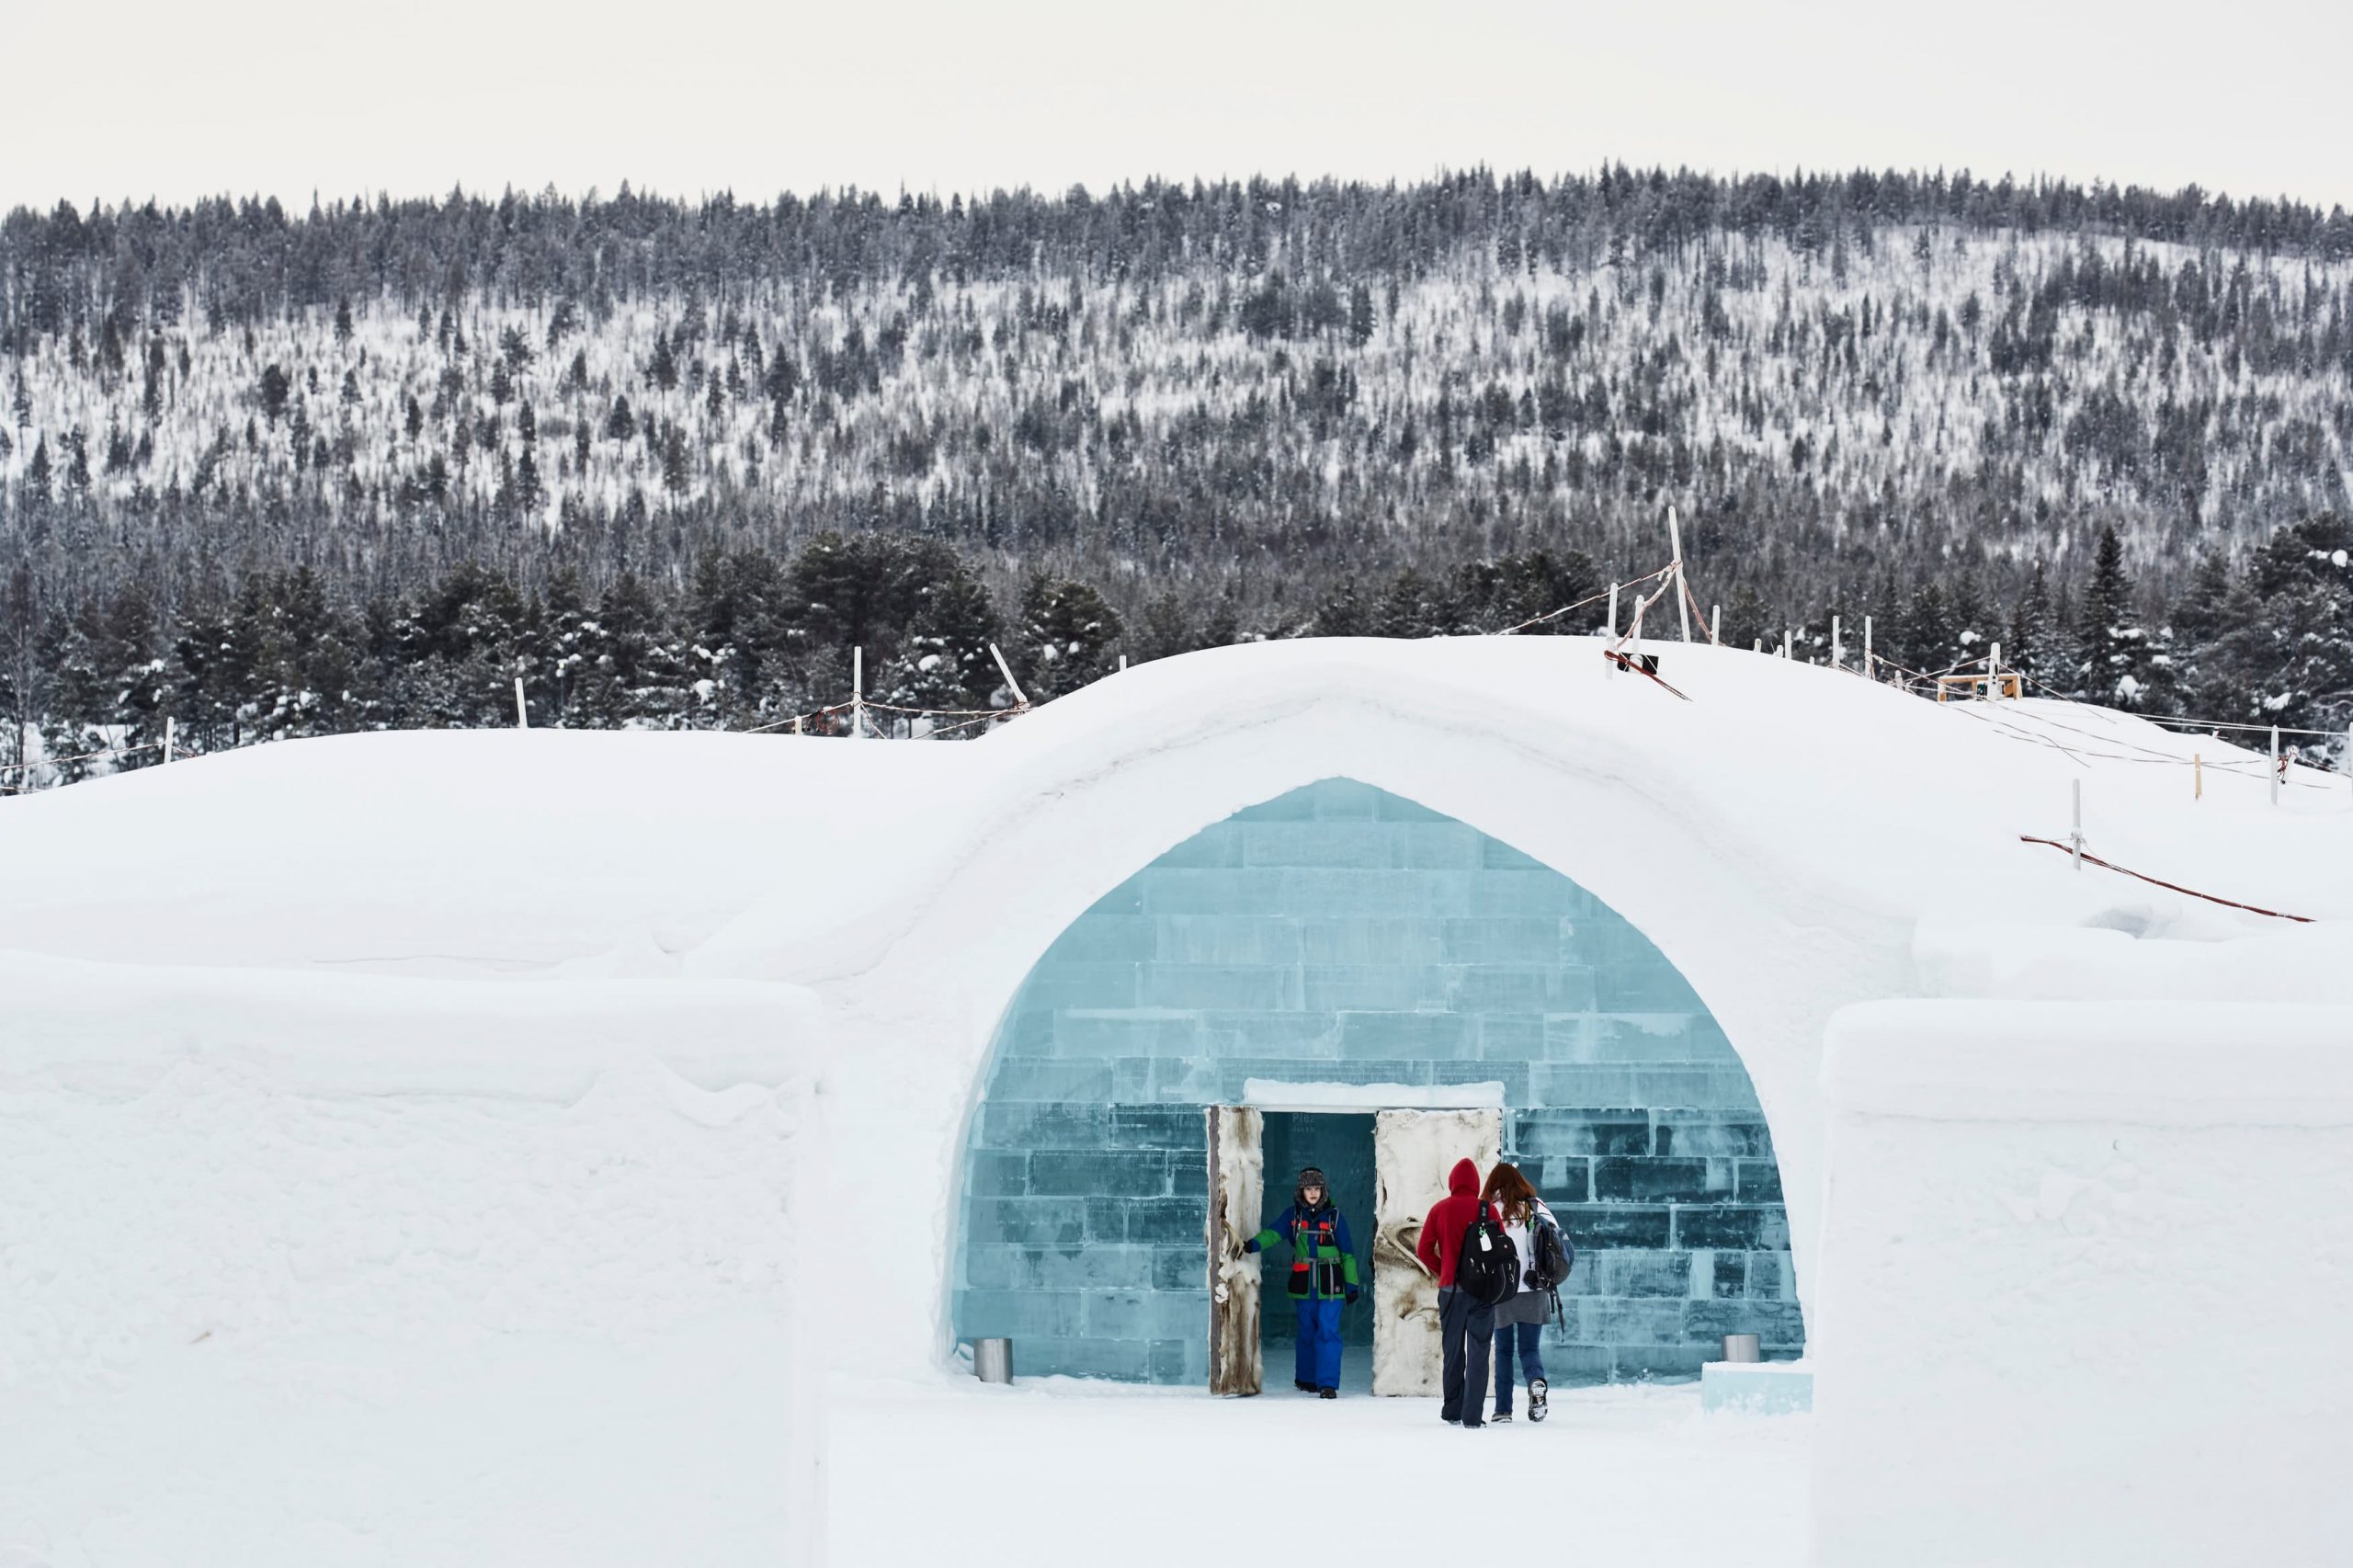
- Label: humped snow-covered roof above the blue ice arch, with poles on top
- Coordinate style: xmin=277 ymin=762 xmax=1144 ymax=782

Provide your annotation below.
xmin=0 ymin=638 xmax=2353 ymax=980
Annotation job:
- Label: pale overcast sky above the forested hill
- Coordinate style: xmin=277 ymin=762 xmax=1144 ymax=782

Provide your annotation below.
xmin=0 ymin=0 xmax=2353 ymax=207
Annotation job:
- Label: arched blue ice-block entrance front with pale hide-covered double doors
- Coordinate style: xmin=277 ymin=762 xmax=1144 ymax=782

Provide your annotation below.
xmin=949 ymin=779 xmax=1805 ymax=1392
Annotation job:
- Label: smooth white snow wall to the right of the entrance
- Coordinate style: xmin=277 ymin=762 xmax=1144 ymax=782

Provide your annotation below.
xmin=1814 ymin=1001 xmax=2353 ymax=1568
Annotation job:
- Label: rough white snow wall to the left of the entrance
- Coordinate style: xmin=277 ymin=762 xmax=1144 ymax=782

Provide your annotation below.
xmin=0 ymin=953 xmax=821 ymax=1568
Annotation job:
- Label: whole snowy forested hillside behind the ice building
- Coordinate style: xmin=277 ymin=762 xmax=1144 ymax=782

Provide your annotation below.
xmin=0 ymin=169 xmax=2353 ymax=777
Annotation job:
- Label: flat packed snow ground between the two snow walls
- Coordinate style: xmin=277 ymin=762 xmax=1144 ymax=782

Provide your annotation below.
xmin=831 ymin=1368 xmax=1810 ymax=1568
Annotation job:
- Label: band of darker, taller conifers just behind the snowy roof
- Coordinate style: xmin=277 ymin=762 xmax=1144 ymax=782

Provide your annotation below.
xmin=0 ymin=513 xmax=2353 ymax=787
